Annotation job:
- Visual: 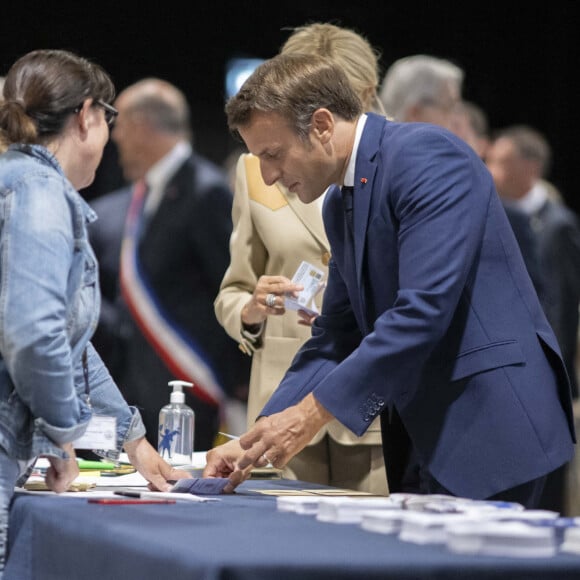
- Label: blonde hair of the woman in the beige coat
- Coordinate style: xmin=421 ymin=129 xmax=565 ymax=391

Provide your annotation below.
xmin=280 ymin=23 xmax=384 ymax=114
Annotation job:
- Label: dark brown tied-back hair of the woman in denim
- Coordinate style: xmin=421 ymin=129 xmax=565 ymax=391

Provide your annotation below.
xmin=0 ymin=50 xmax=115 ymax=144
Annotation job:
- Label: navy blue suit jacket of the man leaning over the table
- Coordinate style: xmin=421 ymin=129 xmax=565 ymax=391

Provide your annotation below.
xmin=263 ymin=114 xmax=574 ymax=498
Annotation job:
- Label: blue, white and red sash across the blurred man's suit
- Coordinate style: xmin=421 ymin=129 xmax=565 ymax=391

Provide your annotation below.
xmin=120 ymin=182 xmax=225 ymax=405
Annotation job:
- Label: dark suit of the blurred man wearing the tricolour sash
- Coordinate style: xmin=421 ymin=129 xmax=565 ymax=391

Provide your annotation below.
xmin=90 ymin=154 xmax=249 ymax=450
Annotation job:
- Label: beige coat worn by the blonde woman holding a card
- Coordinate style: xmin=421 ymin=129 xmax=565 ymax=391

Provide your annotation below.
xmin=215 ymin=155 xmax=381 ymax=445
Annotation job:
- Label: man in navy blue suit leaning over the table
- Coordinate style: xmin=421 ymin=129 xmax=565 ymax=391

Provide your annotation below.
xmin=204 ymin=55 xmax=575 ymax=507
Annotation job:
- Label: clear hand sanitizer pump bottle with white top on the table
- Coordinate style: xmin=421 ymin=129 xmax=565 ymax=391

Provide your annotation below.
xmin=158 ymin=381 xmax=195 ymax=465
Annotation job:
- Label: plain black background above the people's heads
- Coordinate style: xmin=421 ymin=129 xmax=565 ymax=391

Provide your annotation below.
xmin=0 ymin=0 xmax=580 ymax=211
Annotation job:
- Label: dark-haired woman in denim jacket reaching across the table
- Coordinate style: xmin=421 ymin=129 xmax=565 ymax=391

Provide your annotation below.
xmin=0 ymin=50 xmax=188 ymax=577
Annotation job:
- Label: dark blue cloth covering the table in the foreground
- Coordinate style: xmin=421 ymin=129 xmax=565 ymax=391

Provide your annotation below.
xmin=4 ymin=480 xmax=580 ymax=580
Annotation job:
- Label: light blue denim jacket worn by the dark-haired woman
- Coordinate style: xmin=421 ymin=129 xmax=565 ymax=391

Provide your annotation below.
xmin=0 ymin=145 xmax=145 ymax=459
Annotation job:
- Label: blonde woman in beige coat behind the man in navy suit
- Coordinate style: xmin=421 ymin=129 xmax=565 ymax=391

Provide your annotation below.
xmin=215 ymin=23 xmax=388 ymax=495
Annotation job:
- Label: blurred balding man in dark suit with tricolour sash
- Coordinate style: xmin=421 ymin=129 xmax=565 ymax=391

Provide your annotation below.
xmin=90 ymin=78 xmax=249 ymax=450
